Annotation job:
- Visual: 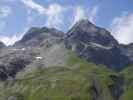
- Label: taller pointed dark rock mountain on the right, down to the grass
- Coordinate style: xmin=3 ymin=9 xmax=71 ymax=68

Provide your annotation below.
xmin=65 ymin=20 xmax=130 ymax=70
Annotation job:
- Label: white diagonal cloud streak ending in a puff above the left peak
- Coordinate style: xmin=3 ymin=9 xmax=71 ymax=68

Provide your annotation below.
xmin=21 ymin=0 xmax=64 ymax=28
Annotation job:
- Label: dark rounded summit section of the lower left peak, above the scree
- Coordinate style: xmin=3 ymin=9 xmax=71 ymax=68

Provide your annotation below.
xmin=15 ymin=27 xmax=64 ymax=46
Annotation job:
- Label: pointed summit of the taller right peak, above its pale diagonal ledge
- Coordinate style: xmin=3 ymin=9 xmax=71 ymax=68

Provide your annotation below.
xmin=66 ymin=19 xmax=118 ymax=46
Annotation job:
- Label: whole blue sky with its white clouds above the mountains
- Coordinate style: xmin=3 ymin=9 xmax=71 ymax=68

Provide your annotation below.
xmin=0 ymin=0 xmax=133 ymax=45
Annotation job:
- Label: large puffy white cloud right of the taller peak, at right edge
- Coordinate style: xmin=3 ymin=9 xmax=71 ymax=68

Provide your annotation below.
xmin=110 ymin=12 xmax=133 ymax=44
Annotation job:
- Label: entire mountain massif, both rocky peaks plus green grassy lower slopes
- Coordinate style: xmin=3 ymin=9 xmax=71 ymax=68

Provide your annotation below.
xmin=0 ymin=20 xmax=133 ymax=100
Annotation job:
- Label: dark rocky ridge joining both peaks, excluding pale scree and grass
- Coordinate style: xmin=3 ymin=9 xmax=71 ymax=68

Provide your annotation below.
xmin=1 ymin=19 xmax=133 ymax=70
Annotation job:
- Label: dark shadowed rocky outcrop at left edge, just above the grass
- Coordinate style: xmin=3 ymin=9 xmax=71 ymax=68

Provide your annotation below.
xmin=0 ymin=51 xmax=33 ymax=80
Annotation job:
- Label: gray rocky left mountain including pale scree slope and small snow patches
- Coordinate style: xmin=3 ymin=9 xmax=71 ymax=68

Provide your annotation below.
xmin=0 ymin=27 xmax=66 ymax=80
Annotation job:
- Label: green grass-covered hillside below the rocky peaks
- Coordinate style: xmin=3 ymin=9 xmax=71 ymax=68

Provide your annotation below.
xmin=0 ymin=52 xmax=133 ymax=100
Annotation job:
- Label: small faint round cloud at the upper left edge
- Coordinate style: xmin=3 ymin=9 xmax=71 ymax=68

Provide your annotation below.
xmin=0 ymin=6 xmax=12 ymax=18
